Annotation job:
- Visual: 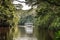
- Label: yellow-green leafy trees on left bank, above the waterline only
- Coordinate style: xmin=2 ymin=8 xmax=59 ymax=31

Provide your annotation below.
xmin=0 ymin=0 xmax=19 ymax=26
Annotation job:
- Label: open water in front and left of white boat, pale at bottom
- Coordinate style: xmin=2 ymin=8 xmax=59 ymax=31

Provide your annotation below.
xmin=14 ymin=28 xmax=37 ymax=40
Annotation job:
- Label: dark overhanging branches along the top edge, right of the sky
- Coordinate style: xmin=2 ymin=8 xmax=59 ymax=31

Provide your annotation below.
xmin=26 ymin=0 xmax=60 ymax=6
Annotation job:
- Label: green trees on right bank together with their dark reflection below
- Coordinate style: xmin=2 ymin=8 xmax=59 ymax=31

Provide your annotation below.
xmin=34 ymin=0 xmax=60 ymax=40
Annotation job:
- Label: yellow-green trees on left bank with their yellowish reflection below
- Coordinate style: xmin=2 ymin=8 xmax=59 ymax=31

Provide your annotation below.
xmin=0 ymin=0 xmax=19 ymax=40
